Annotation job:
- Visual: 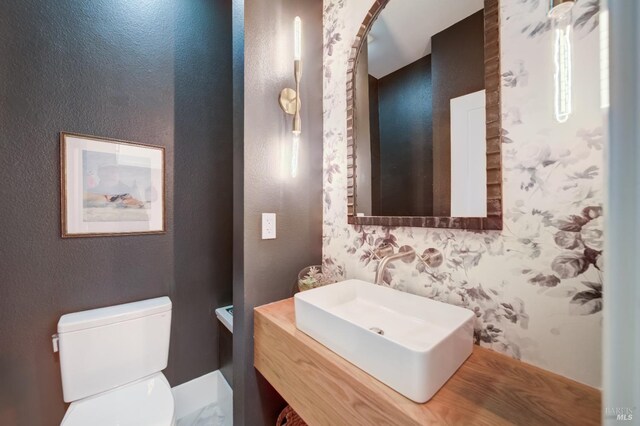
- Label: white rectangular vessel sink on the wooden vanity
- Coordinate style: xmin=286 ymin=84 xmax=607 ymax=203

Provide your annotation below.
xmin=295 ymin=280 xmax=474 ymax=403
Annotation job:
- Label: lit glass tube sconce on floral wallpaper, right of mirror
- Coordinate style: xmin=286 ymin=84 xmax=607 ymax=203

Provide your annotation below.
xmin=548 ymin=0 xmax=575 ymax=123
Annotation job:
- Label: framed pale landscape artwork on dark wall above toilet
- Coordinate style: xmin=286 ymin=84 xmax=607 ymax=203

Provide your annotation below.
xmin=60 ymin=132 xmax=165 ymax=238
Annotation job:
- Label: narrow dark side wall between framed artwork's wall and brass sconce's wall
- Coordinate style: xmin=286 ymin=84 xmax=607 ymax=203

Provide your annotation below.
xmin=171 ymin=0 xmax=233 ymax=390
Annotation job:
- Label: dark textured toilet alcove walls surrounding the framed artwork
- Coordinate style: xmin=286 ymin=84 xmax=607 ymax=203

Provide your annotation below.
xmin=0 ymin=0 xmax=231 ymax=425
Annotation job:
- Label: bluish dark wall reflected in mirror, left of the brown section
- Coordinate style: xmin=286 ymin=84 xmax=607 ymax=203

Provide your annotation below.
xmin=370 ymin=55 xmax=433 ymax=216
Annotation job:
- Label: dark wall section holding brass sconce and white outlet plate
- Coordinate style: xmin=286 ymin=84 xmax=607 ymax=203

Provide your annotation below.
xmin=233 ymin=0 xmax=322 ymax=426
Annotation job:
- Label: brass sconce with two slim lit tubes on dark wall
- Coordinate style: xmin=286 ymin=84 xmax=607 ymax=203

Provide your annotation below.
xmin=279 ymin=16 xmax=302 ymax=177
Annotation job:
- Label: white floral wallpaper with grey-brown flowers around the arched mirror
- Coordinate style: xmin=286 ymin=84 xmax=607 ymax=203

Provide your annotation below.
xmin=323 ymin=0 xmax=604 ymax=386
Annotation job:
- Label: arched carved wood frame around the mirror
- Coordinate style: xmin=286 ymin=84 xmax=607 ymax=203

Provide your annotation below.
xmin=347 ymin=0 xmax=502 ymax=230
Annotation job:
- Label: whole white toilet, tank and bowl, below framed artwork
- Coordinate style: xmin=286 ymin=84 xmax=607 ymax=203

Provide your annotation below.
xmin=54 ymin=297 xmax=175 ymax=426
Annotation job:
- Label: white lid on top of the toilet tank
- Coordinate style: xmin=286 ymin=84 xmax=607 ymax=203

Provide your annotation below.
xmin=58 ymin=296 xmax=171 ymax=333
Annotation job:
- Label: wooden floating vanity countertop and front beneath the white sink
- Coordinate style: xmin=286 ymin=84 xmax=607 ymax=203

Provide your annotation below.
xmin=254 ymin=299 xmax=601 ymax=426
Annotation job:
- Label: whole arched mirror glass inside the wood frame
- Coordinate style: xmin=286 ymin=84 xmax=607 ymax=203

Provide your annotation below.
xmin=355 ymin=0 xmax=487 ymax=217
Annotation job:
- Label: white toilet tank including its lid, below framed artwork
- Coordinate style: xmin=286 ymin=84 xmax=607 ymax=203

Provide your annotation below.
xmin=57 ymin=297 xmax=171 ymax=402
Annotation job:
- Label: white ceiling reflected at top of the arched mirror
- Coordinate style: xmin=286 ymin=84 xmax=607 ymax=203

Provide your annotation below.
xmin=369 ymin=0 xmax=484 ymax=78
